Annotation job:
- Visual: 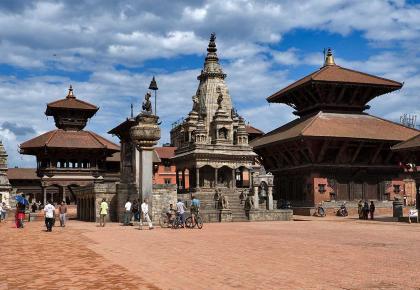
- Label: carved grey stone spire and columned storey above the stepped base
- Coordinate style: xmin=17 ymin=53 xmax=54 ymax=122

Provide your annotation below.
xmin=171 ymin=33 xmax=256 ymax=204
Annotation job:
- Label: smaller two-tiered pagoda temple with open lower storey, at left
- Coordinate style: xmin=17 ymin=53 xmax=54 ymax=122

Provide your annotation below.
xmin=20 ymin=86 xmax=120 ymax=204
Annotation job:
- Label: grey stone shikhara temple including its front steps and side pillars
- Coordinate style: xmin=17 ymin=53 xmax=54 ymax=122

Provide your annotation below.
xmin=171 ymin=33 xmax=292 ymax=221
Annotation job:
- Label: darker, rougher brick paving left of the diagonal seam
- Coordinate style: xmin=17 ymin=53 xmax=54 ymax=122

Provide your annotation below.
xmin=0 ymin=221 xmax=157 ymax=290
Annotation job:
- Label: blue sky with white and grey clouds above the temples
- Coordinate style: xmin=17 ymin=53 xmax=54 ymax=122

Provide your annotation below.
xmin=0 ymin=0 xmax=420 ymax=167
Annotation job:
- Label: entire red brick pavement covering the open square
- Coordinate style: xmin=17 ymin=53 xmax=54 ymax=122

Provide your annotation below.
xmin=0 ymin=217 xmax=420 ymax=289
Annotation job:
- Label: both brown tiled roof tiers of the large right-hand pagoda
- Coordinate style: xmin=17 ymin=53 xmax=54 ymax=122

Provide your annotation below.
xmin=251 ymin=49 xmax=419 ymax=149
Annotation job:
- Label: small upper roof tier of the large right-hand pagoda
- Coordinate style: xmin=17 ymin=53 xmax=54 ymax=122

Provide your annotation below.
xmin=267 ymin=49 xmax=403 ymax=116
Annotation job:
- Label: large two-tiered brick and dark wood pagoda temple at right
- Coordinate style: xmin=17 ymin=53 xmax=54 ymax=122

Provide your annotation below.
xmin=251 ymin=49 xmax=419 ymax=213
